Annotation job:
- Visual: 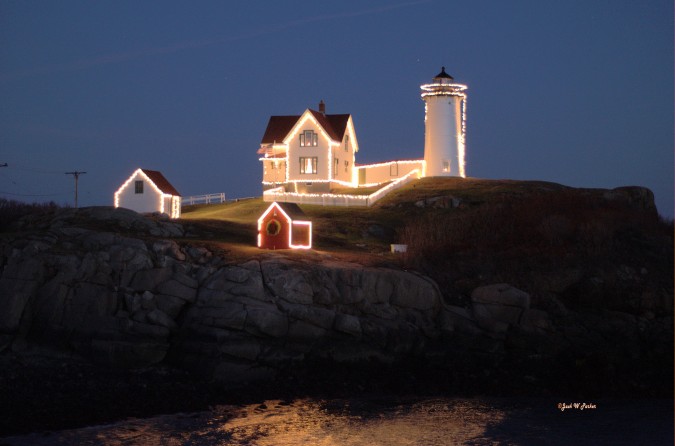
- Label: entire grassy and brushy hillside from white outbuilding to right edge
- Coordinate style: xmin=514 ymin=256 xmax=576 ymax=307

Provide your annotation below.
xmin=178 ymin=178 xmax=673 ymax=306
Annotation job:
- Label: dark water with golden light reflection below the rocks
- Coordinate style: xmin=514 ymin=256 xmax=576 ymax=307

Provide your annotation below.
xmin=0 ymin=398 xmax=673 ymax=446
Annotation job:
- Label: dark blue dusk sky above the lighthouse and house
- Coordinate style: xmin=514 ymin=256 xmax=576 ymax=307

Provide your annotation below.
xmin=0 ymin=0 xmax=674 ymax=217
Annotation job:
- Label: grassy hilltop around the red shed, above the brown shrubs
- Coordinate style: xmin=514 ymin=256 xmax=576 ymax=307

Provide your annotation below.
xmin=182 ymin=178 xmax=655 ymax=251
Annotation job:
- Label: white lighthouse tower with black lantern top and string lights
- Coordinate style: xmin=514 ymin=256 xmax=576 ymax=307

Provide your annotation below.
xmin=420 ymin=67 xmax=467 ymax=177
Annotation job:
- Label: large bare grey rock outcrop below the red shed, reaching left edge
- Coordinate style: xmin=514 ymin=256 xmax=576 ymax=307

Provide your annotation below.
xmin=0 ymin=208 xmax=442 ymax=379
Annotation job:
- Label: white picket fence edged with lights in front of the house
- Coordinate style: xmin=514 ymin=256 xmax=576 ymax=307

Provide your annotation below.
xmin=263 ymin=169 xmax=420 ymax=206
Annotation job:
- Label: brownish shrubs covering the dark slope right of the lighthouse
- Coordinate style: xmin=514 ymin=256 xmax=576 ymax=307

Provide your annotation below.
xmin=400 ymin=190 xmax=672 ymax=265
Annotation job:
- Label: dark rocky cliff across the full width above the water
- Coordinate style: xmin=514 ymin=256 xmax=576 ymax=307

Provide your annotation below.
xmin=0 ymin=202 xmax=673 ymax=400
